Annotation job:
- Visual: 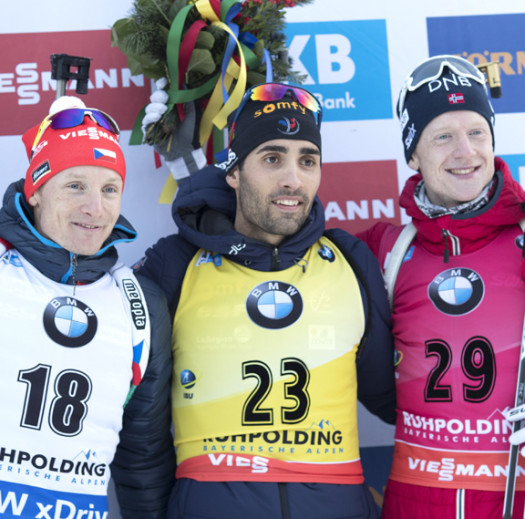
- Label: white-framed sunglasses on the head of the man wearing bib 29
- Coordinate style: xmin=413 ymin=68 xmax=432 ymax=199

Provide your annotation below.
xmin=397 ymin=54 xmax=485 ymax=117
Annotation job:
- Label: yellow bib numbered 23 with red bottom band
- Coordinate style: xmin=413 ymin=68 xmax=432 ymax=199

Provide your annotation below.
xmin=173 ymin=237 xmax=365 ymax=483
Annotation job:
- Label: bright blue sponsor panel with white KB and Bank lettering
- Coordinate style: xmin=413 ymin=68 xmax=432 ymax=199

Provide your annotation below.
xmin=286 ymin=20 xmax=393 ymax=121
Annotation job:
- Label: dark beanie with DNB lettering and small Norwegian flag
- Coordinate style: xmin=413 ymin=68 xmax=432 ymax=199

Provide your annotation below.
xmin=398 ymin=66 xmax=494 ymax=163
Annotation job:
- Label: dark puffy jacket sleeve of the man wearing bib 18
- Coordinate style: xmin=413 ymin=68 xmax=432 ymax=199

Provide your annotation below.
xmin=111 ymin=275 xmax=175 ymax=519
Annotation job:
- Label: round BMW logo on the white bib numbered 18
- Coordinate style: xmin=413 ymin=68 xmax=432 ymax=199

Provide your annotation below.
xmin=44 ymin=297 xmax=97 ymax=348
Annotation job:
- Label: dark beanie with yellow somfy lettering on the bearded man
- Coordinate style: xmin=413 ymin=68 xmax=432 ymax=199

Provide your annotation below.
xmin=218 ymin=95 xmax=321 ymax=171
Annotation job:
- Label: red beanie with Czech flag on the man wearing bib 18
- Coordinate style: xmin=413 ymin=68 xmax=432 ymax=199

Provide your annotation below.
xmin=22 ymin=98 xmax=126 ymax=200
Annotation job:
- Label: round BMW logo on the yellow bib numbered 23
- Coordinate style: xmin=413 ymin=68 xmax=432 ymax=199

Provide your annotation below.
xmin=246 ymin=281 xmax=303 ymax=330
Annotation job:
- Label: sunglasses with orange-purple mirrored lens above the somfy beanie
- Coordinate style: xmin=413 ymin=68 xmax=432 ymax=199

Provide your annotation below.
xmin=228 ymin=83 xmax=323 ymax=147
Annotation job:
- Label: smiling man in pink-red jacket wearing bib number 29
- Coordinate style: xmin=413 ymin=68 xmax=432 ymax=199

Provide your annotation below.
xmin=359 ymin=56 xmax=525 ymax=519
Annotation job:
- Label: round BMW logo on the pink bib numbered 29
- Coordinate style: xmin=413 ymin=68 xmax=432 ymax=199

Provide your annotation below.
xmin=428 ymin=268 xmax=485 ymax=315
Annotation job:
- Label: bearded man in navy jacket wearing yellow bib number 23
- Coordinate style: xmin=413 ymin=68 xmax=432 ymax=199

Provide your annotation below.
xmin=139 ymin=83 xmax=395 ymax=519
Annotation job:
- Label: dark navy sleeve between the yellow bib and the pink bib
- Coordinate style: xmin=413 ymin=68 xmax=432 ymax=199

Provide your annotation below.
xmin=326 ymin=229 xmax=396 ymax=424
